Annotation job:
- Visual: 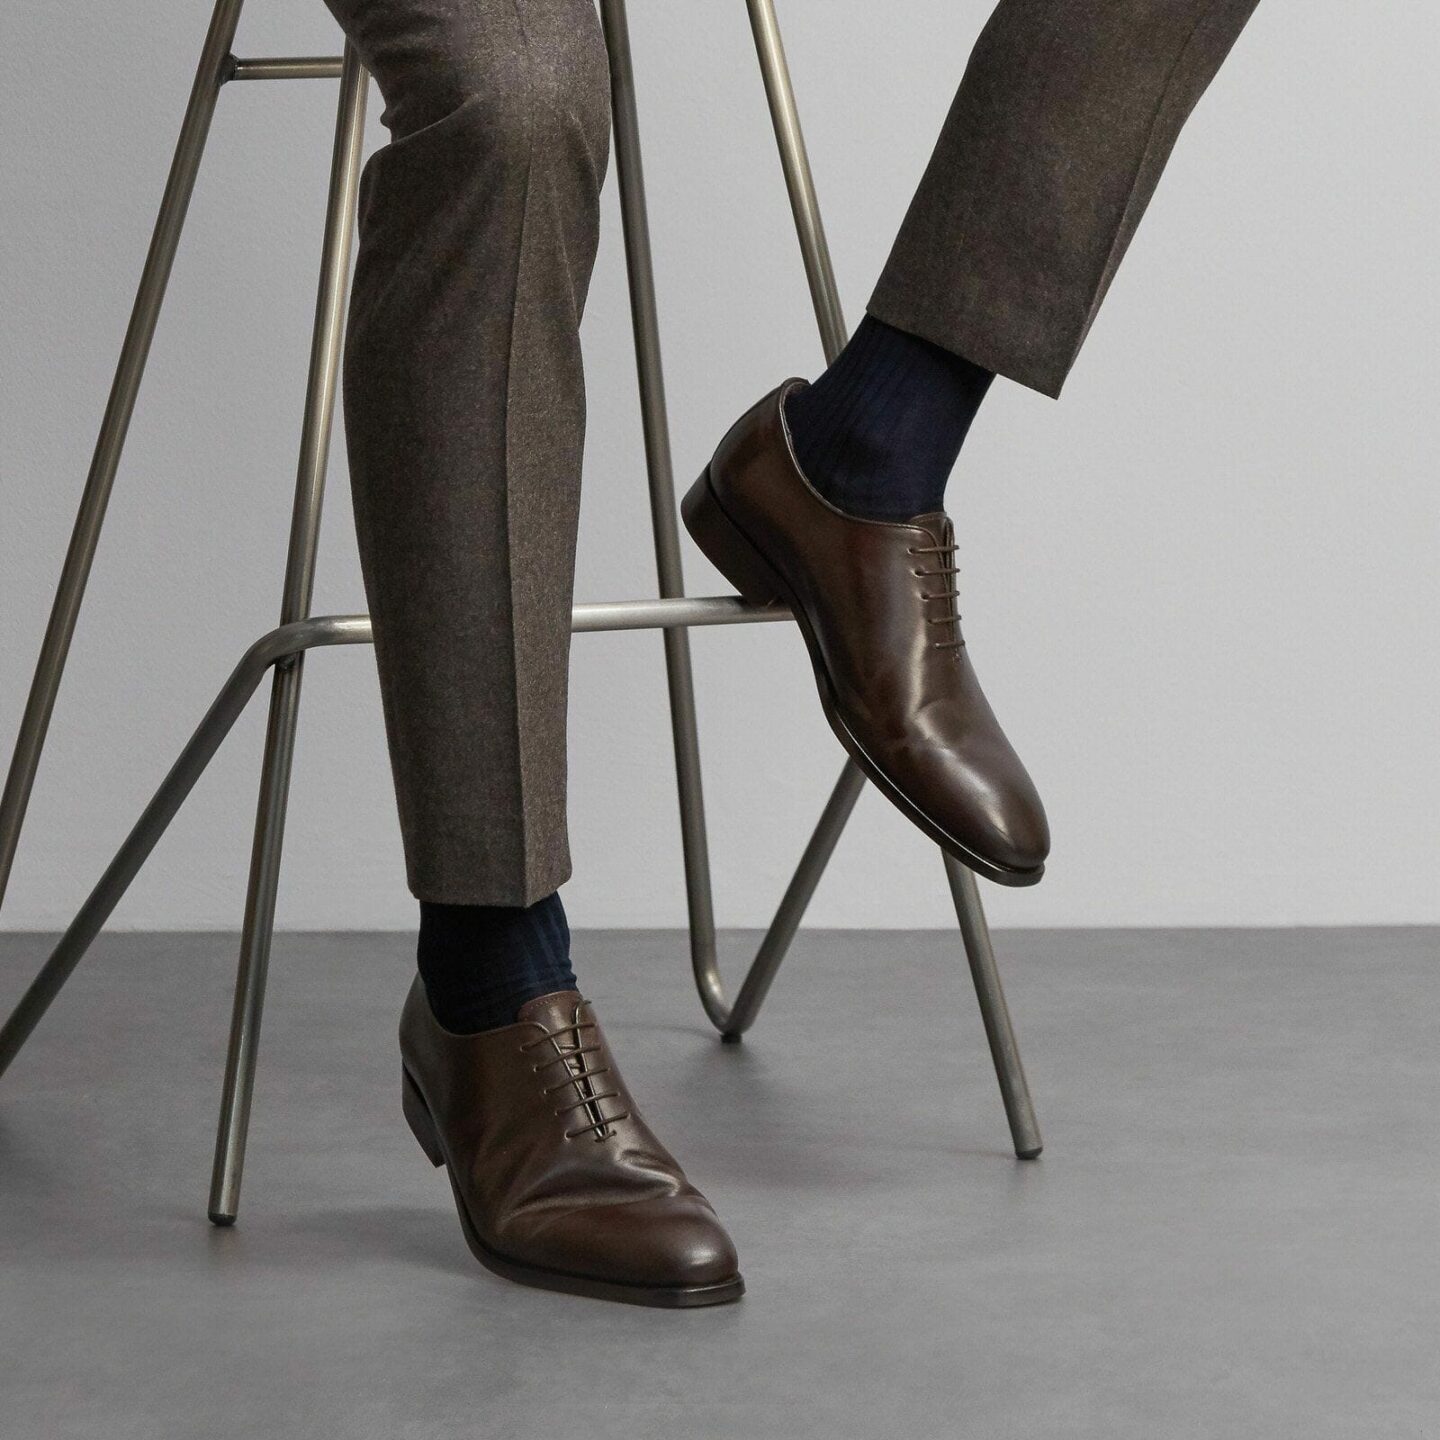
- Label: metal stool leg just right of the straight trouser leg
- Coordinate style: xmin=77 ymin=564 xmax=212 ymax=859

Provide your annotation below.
xmin=600 ymin=0 xmax=724 ymax=1024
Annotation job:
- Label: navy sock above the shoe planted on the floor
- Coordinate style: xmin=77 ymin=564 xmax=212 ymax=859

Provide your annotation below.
xmin=416 ymin=894 xmax=576 ymax=1035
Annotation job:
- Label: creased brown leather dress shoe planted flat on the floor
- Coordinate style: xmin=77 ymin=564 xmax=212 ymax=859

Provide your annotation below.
xmin=400 ymin=978 xmax=744 ymax=1308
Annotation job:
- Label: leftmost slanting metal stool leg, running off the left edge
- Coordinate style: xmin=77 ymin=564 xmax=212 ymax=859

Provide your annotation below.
xmin=0 ymin=0 xmax=243 ymax=901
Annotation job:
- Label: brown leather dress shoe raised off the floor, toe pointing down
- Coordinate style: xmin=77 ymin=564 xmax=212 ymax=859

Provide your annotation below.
xmin=681 ymin=380 xmax=1050 ymax=886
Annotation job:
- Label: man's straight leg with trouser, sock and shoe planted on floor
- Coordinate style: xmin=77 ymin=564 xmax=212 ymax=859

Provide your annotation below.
xmin=327 ymin=0 xmax=742 ymax=1305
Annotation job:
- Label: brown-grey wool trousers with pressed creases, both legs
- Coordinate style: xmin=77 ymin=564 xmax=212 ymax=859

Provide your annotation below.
xmin=325 ymin=0 xmax=1259 ymax=906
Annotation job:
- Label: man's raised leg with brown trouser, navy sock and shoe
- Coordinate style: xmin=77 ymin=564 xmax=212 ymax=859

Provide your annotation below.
xmin=685 ymin=0 xmax=1257 ymax=884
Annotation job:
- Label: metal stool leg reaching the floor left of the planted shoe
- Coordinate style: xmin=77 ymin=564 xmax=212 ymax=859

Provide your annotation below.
xmin=209 ymin=53 xmax=369 ymax=1225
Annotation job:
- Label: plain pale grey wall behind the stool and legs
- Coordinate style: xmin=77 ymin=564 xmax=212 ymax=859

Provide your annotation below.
xmin=0 ymin=0 xmax=1440 ymax=929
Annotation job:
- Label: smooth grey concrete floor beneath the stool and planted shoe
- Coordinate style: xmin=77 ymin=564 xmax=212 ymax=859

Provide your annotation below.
xmin=0 ymin=930 xmax=1440 ymax=1440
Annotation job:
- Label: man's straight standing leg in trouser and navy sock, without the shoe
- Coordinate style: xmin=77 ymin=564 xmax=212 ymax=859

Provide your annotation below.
xmin=331 ymin=0 xmax=609 ymax=1031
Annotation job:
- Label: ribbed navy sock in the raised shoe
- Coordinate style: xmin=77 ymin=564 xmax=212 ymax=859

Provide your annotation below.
xmin=785 ymin=315 xmax=995 ymax=520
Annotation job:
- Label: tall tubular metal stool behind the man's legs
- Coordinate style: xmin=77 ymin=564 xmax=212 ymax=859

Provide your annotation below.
xmin=0 ymin=0 xmax=1041 ymax=1225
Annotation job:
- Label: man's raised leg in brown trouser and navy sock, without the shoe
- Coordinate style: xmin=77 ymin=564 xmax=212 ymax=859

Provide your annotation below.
xmin=788 ymin=0 xmax=1257 ymax=520
